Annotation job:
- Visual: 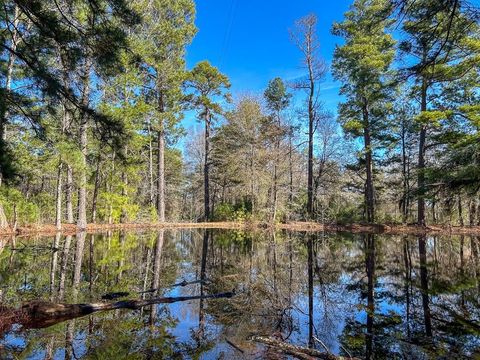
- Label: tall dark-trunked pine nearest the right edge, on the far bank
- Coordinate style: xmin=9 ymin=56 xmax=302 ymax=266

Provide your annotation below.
xmin=400 ymin=0 xmax=479 ymax=225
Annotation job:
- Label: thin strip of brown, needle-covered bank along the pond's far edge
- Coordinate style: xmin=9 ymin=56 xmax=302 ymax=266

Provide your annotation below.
xmin=0 ymin=221 xmax=480 ymax=237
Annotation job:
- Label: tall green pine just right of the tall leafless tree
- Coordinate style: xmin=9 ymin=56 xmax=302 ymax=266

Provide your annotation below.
xmin=333 ymin=0 xmax=395 ymax=222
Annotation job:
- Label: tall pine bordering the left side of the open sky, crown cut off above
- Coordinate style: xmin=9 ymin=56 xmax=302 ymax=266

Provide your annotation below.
xmin=135 ymin=0 xmax=196 ymax=222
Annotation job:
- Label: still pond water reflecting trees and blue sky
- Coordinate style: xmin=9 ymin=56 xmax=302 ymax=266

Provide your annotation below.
xmin=0 ymin=229 xmax=480 ymax=359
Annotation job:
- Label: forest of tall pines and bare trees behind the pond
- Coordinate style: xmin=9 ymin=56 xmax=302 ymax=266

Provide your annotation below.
xmin=0 ymin=0 xmax=480 ymax=229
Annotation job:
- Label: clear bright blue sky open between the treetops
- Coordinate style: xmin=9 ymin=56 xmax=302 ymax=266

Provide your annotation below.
xmin=185 ymin=0 xmax=352 ymax=132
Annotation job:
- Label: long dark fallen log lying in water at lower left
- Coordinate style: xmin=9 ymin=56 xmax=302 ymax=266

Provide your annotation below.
xmin=0 ymin=291 xmax=235 ymax=333
